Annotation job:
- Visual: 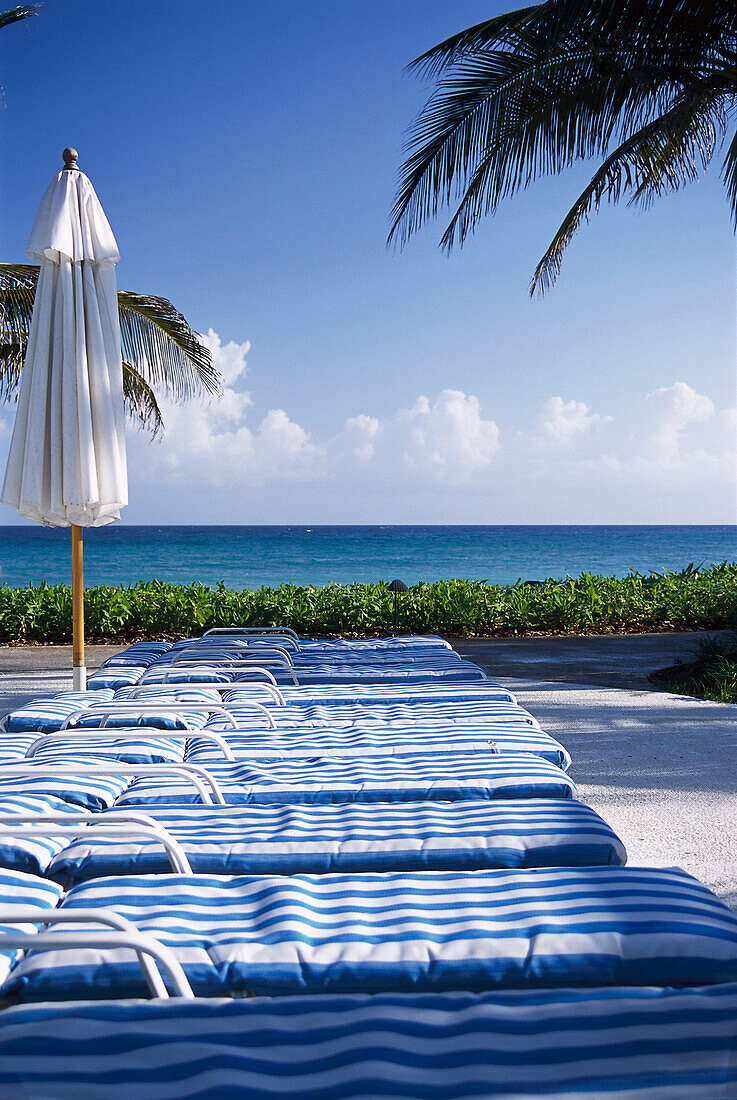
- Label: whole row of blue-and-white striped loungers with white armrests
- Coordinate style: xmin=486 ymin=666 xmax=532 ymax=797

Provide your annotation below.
xmin=0 ymin=628 xmax=737 ymax=1100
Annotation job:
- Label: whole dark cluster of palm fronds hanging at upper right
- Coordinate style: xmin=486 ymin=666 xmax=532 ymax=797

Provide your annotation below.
xmin=389 ymin=0 xmax=737 ymax=293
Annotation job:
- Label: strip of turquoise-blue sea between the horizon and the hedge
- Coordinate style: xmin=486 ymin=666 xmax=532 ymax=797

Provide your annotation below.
xmin=0 ymin=526 xmax=737 ymax=589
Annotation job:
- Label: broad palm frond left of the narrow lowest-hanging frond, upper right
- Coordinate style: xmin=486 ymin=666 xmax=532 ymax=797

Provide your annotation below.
xmin=389 ymin=40 xmax=668 ymax=246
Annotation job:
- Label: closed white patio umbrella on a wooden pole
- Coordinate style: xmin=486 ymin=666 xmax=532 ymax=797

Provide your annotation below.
xmin=1 ymin=149 xmax=128 ymax=689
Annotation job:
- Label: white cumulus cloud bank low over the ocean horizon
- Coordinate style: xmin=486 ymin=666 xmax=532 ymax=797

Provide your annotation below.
xmin=117 ymin=330 xmax=737 ymax=524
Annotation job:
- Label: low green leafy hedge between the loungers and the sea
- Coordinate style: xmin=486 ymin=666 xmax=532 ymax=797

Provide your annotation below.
xmin=0 ymin=562 xmax=737 ymax=642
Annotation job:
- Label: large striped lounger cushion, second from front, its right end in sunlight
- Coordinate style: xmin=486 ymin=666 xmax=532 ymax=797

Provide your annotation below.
xmin=2 ymin=867 xmax=737 ymax=1000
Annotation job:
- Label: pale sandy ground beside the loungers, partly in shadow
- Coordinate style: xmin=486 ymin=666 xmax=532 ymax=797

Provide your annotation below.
xmin=0 ymin=634 xmax=737 ymax=910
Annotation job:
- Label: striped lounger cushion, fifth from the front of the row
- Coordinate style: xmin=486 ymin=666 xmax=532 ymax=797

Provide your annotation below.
xmin=187 ymin=712 xmax=571 ymax=769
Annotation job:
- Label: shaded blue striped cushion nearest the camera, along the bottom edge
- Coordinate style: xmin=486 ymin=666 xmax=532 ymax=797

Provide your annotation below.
xmin=0 ymin=983 xmax=737 ymax=1100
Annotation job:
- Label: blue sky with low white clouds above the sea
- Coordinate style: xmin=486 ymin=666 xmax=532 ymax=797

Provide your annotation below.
xmin=0 ymin=0 xmax=736 ymax=524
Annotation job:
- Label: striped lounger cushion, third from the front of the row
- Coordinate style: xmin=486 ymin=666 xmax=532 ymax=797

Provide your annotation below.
xmin=47 ymin=799 xmax=626 ymax=888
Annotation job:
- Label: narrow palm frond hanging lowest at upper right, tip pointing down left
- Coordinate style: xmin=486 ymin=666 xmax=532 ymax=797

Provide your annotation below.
xmin=530 ymin=90 xmax=716 ymax=294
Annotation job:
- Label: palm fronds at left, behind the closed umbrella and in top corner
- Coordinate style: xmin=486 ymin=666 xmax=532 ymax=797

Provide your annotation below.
xmin=0 ymin=4 xmax=222 ymax=435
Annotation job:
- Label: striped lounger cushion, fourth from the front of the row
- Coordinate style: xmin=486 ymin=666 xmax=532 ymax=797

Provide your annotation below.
xmin=118 ymin=752 xmax=575 ymax=806
